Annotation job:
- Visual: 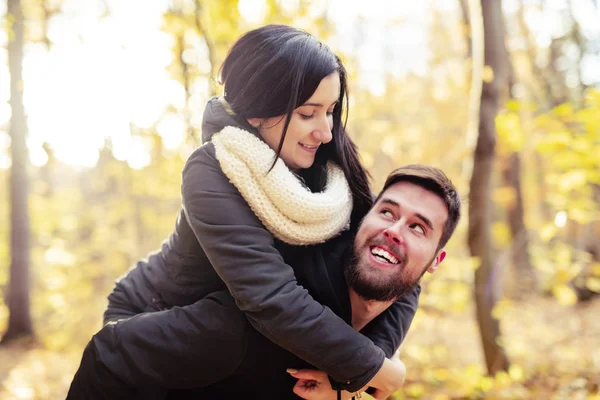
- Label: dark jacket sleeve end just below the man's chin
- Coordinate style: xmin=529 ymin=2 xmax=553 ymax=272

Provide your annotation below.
xmin=361 ymin=285 xmax=421 ymax=358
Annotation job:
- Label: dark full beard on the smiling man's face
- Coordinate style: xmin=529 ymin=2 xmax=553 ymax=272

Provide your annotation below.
xmin=344 ymin=240 xmax=435 ymax=301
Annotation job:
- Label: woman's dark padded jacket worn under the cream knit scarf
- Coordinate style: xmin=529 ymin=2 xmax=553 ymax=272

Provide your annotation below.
xmin=92 ymin=100 xmax=418 ymax=391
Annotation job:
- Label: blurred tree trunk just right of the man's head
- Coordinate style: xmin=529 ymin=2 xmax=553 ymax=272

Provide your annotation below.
xmin=468 ymin=0 xmax=509 ymax=374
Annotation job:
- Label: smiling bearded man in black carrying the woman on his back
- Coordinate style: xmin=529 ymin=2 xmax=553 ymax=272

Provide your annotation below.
xmin=68 ymin=165 xmax=461 ymax=400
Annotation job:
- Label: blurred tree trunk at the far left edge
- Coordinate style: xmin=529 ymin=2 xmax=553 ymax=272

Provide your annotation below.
xmin=2 ymin=0 xmax=33 ymax=343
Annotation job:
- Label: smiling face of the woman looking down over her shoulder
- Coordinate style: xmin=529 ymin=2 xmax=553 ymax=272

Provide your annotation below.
xmin=248 ymin=72 xmax=340 ymax=170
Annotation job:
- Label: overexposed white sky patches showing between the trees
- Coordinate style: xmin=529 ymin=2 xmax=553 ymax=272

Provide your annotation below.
xmin=0 ymin=0 xmax=600 ymax=169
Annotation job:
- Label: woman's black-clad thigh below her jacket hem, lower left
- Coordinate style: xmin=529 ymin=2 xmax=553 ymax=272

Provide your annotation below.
xmin=89 ymin=291 xmax=249 ymax=389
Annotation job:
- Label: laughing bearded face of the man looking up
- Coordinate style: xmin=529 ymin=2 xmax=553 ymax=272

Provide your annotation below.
xmin=345 ymin=182 xmax=448 ymax=301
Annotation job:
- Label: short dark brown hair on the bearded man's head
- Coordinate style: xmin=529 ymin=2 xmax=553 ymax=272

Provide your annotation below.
xmin=375 ymin=164 xmax=461 ymax=250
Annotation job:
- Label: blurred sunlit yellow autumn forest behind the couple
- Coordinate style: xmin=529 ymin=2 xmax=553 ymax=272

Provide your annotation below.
xmin=0 ymin=0 xmax=600 ymax=400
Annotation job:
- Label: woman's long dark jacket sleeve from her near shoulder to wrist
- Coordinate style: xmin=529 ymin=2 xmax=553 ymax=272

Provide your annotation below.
xmin=182 ymin=143 xmax=385 ymax=391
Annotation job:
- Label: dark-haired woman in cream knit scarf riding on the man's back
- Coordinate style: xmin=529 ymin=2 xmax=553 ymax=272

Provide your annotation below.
xmin=69 ymin=25 xmax=418 ymax=400
